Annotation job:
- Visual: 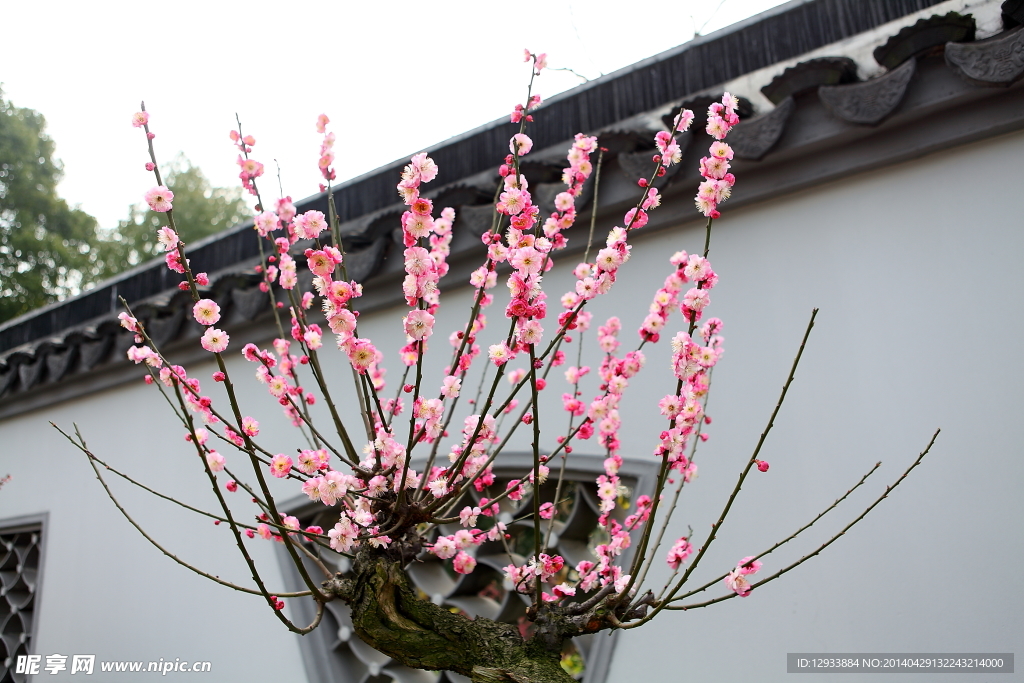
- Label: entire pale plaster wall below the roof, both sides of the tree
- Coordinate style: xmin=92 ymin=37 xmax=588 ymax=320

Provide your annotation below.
xmin=0 ymin=126 xmax=1024 ymax=682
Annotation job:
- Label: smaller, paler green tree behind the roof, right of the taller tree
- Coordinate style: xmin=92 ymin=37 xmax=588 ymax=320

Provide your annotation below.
xmin=92 ymin=155 xmax=250 ymax=281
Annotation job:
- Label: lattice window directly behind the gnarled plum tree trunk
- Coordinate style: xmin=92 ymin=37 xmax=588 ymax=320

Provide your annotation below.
xmin=281 ymin=454 xmax=656 ymax=683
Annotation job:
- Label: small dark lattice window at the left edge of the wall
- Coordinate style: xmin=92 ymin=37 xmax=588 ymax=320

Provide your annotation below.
xmin=0 ymin=518 xmax=43 ymax=683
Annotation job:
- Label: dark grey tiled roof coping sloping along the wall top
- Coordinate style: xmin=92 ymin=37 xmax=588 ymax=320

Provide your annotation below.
xmin=0 ymin=0 xmax=1024 ymax=413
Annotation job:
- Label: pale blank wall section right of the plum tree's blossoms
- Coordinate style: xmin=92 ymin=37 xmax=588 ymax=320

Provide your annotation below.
xmin=609 ymin=132 xmax=1024 ymax=682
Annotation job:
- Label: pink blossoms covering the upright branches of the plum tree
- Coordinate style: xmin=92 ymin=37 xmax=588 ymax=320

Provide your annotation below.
xmin=122 ymin=61 xmax=767 ymax=626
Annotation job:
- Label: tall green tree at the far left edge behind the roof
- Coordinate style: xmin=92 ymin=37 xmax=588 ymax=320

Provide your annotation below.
xmin=0 ymin=90 xmax=96 ymax=322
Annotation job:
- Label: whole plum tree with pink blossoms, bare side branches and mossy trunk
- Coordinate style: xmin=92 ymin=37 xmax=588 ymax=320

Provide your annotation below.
xmin=54 ymin=51 xmax=938 ymax=683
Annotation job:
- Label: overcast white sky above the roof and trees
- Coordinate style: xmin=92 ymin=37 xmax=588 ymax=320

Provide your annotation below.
xmin=0 ymin=0 xmax=783 ymax=227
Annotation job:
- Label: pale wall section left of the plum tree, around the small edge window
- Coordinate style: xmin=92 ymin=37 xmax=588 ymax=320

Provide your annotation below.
xmin=0 ymin=356 xmax=302 ymax=681
